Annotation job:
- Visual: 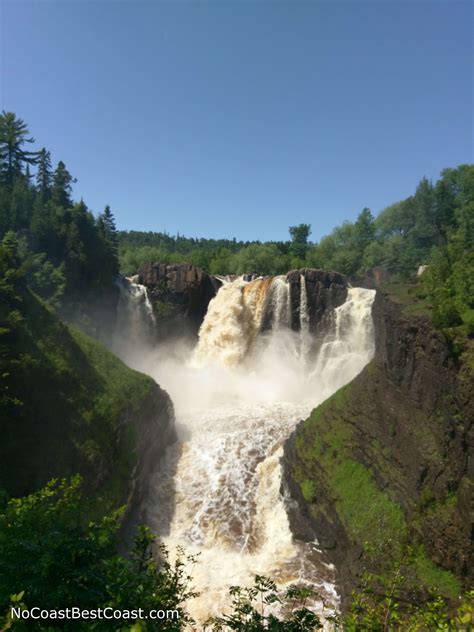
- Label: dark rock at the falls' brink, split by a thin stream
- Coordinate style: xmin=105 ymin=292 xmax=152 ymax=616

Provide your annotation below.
xmin=286 ymin=268 xmax=347 ymax=334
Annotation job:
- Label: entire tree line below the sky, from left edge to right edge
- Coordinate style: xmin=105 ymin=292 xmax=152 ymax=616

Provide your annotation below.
xmin=0 ymin=111 xmax=474 ymax=328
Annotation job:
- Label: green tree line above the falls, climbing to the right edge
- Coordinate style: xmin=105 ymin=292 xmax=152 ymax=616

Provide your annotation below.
xmin=118 ymin=165 xmax=474 ymax=331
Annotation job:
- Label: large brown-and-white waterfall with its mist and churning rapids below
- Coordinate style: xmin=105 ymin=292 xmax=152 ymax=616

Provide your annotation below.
xmin=115 ymin=277 xmax=374 ymax=621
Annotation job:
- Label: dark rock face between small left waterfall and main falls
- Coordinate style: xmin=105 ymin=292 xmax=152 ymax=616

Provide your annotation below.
xmin=137 ymin=262 xmax=222 ymax=337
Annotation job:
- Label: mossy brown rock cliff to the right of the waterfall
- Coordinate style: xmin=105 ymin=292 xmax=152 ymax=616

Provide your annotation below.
xmin=283 ymin=291 xmax=474 ymax=606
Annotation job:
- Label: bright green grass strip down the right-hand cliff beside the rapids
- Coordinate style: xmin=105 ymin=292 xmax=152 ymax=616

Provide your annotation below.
xmin=293 ymin=380 xmax=460 ymax=598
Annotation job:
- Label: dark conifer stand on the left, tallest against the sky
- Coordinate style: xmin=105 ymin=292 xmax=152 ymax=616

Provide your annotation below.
xmin=0 ymin=111 xmax=119 ymax=314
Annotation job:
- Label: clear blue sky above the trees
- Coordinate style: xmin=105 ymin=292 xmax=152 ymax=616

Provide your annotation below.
xmin=0 ymin=0 xmax=473 ymax=240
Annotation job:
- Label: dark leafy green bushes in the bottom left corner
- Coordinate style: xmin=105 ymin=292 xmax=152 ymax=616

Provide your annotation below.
xmin=0 ymin=477 xmax=194 ymax=632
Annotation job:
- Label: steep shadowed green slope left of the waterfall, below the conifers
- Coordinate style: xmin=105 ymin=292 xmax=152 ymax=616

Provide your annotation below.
xmin=0 ymin=287 xmax=174 ymax=509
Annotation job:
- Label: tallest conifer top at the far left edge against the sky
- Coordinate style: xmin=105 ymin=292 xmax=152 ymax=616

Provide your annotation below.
xmin=0 ymin=110 xmax=38 ymax=184
